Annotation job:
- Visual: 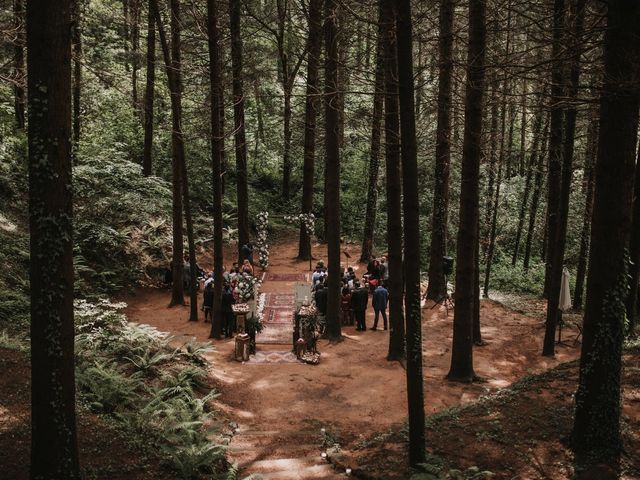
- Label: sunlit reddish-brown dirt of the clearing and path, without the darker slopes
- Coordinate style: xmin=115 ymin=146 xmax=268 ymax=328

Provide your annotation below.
xmin=125 ymin=243 xmax=579 ymax=480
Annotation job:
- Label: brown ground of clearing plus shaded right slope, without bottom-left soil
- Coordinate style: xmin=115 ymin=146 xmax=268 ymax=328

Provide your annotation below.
xmin=117 ymin=241 xmax=640 ymax=479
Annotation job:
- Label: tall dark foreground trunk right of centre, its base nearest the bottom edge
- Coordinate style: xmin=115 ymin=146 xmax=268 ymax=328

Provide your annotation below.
xmin=396 ymin=0 xmax=425 ymax=467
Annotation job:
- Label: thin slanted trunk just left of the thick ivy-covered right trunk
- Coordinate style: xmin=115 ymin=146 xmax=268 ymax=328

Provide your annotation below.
xmin=573 ymin=117 xmax=598 ymax=310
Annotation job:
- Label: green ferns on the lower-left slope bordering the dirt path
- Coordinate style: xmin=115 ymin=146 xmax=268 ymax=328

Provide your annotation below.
xmin=75 ymin=300 xmax=227 ymax=480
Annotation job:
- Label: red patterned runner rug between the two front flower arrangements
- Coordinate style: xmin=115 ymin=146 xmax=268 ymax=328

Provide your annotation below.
xmin=256 ymin=293 xmax=295 ymax=345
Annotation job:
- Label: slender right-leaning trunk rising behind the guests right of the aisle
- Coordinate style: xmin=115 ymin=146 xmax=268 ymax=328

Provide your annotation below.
xmin=360 ymin=1 xmax=384 ymax=262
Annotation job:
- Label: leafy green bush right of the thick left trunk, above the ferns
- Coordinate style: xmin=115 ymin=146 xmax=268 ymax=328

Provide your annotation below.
xmin=74 ymin=158 xmax=171 ymax=295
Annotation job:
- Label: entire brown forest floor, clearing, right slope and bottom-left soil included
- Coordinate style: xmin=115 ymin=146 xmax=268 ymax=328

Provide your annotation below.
xmin=0 ymin=240 xmax=640 ymax=480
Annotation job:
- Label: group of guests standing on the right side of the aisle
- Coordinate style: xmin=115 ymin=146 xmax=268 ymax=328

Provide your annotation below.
xmin=311 ymin=257 xmax=389 ymax=331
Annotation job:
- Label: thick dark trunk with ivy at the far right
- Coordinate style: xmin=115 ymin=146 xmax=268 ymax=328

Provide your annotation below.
xmin=572 ymin=0 xmax=640 ymax=463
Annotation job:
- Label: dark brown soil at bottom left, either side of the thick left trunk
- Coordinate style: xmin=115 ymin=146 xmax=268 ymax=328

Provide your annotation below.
xmin=0 ymin=348 xmax=174 ymax=480
